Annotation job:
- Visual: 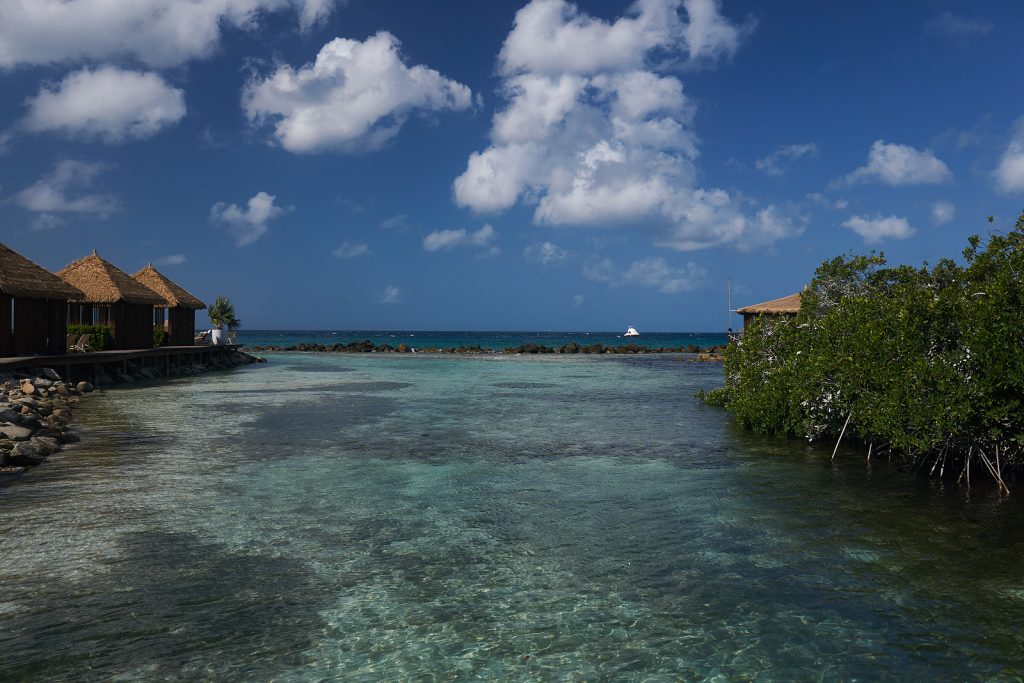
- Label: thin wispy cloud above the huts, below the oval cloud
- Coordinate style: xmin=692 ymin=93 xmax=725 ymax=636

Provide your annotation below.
xmin=14 ymin=159 xmax=121 ymax=219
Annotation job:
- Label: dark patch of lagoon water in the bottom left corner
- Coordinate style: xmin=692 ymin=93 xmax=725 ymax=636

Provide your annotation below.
xmin=0 ymin=529 xmax=336 ymax=680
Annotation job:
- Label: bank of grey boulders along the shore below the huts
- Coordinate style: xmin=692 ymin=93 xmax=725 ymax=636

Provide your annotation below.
xmin=0 ymin=351 xmax=265 ymax=483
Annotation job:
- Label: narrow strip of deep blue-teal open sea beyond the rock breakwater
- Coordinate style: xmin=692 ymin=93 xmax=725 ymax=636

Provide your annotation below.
xmin=237 ymin=329 xmax=727 ymax=351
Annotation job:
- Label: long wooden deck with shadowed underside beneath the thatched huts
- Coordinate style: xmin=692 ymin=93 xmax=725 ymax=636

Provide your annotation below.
xmin=0 ymin=344 xmax=241 ymax=383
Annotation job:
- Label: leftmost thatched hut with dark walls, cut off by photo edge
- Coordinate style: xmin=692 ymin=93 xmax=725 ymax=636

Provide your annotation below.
xmin=0 ymin=244 xmax=82 ymax=355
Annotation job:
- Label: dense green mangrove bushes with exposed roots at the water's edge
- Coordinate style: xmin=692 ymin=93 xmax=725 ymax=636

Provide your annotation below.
xmin=697 ymin=214 xmax=1024 ymax=485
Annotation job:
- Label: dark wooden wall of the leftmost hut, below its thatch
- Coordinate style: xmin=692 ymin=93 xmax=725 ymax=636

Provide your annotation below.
xmin=0 ymin=294 xmax=68 ymax=355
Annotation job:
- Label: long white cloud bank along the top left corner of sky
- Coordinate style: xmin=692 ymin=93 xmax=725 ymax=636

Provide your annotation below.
xmin=0 ymin=0 xmax=337 ymax=68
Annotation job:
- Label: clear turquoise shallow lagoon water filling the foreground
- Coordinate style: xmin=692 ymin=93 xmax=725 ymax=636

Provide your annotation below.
xmin=0 ymin=354 xmax=1024 ymax=681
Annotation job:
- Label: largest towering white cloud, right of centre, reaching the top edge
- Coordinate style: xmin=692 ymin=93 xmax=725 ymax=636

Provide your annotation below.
xmin=454 ymin=0 xmax=799 ymax=250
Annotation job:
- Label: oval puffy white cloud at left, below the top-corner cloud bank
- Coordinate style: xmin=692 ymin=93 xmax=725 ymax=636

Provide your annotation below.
xmin=19 ymin=66 xmax=185 ymax=142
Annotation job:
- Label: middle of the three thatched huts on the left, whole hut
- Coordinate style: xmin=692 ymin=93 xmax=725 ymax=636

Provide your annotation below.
xmin=57 ymin=250 xmax=164 ymax=349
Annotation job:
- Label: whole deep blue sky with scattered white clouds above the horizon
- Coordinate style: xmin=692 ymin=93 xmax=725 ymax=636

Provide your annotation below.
xmin=0 ymin=0 xmax=1024 ymax=332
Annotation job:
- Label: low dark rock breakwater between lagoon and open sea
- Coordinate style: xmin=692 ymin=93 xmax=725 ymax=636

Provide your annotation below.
xmin=248 ymin=339 xmax=725 ymax=360
